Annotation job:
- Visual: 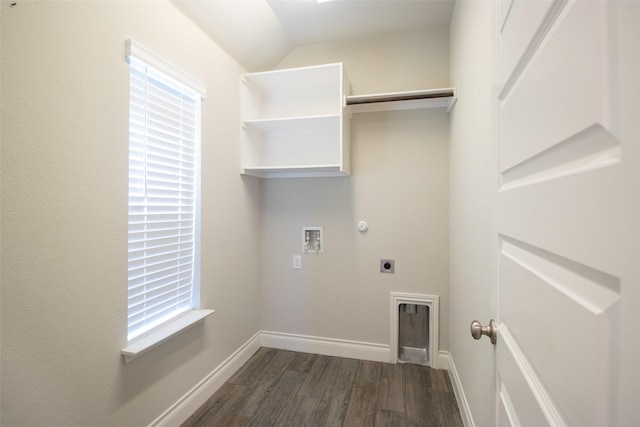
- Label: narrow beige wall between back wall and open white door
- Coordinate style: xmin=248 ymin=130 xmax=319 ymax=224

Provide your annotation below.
xmin=449 ymin=1 xmax=497 ymax=426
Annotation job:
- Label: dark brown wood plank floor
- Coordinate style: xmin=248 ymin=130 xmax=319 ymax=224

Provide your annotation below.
xmin=182 ymin=348 xmax=462 ymax=427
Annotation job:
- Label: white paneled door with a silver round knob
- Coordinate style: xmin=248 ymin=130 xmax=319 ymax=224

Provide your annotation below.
xmin=492 ymin=0 xmax=640 ymax=427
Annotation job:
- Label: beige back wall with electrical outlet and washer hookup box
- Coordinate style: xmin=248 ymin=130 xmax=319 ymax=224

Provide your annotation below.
xmin=260 ymin=28 xmax=449 ymax=349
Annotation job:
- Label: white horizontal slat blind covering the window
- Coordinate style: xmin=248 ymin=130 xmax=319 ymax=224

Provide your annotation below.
xmin=127 ymin=45 xmax=202 ymax=341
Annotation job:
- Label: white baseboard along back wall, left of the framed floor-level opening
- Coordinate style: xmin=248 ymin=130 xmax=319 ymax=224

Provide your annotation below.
xmin=260 ymin=331 xmax=389 ymax=362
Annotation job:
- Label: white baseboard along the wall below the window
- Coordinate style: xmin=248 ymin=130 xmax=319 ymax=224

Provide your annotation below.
xmin=149 ymin=332 xmax=260 ymax=427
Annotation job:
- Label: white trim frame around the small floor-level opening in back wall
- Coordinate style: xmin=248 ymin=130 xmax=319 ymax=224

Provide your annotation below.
xmin=387 ymin=292 xmax=440 ymax=369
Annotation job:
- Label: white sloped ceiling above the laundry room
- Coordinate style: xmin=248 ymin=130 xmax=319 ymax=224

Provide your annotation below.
xmin=173 ymin=0 xmax=454 ymax=71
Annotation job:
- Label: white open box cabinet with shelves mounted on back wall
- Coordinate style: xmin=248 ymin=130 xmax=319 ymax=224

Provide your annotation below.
xmin=240 ymin=64 xmax=350 ymax=178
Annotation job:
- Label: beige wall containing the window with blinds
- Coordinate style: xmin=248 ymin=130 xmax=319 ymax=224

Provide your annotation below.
xmin=0 ymin=1 xmax=259 ymax=426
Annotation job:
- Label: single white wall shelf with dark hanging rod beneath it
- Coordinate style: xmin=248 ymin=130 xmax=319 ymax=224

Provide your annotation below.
xmin=345 ymin=88 xmax=456 ymax=113
